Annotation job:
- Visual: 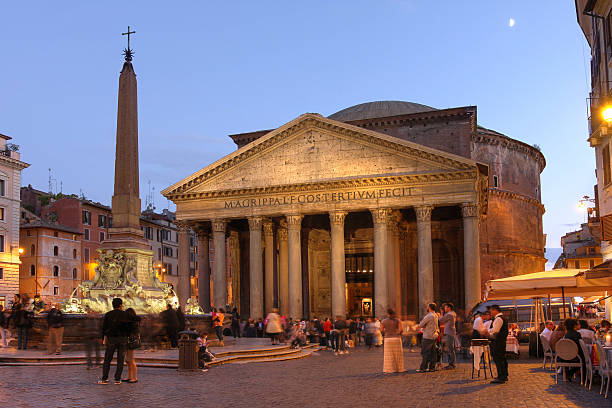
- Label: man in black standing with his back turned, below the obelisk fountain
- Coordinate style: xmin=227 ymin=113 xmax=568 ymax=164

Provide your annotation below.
xmin=98 ymin=298 xmax=132 ymax=384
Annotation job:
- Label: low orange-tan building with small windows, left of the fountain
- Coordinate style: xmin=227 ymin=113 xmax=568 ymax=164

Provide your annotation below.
xmin=19 ymin=221 xmax=83 ymax=303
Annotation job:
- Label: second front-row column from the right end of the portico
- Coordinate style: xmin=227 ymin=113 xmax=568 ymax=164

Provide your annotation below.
xmin=414 ymin=205 xmax=434 ymax=317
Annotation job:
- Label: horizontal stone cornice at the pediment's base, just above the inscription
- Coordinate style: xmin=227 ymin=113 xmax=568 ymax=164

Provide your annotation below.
xmin=167 ymin=169 xmax=478 ymax=201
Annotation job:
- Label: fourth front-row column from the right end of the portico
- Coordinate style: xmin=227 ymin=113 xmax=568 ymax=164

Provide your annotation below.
xmin=329 ymin=211 xmax=347 ymax=317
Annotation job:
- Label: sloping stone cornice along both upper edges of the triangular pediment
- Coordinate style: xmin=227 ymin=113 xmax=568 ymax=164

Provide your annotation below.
xmin=162 ymin=114 xmax=474 ymax=200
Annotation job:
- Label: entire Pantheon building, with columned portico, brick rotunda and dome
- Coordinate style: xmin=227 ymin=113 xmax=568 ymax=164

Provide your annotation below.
xmin=162 ymin=101 xmax=546 ymax=318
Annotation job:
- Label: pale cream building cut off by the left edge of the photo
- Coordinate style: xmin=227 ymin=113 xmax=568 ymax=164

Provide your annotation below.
xmin=0 ymin=134 xmax=29 ymax=306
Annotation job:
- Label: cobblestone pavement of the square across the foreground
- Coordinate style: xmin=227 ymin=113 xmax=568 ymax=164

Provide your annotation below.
xmin=0 ymin=350 xmax=612 ymax=408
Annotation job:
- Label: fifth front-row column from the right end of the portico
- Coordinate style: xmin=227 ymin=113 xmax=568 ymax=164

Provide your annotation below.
xmin=287 ymin=215 xmax=303 ymax=319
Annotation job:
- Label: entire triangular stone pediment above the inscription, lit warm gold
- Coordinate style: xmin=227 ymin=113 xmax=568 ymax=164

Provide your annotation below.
xmin=162 ymin=113 xmax=477 ymax=198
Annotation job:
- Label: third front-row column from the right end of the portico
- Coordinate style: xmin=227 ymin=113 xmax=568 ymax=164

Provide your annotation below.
xmin=371 ymin=208 xmax=391 ymax=320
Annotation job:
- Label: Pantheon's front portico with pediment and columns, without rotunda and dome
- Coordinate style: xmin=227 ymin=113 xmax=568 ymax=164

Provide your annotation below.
xmin=162 ymin=114 xmax=487 ymax=318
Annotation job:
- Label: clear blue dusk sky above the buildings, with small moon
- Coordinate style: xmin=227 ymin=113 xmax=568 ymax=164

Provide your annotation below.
xmin=0 ymin=0 xmax=596 ymax=252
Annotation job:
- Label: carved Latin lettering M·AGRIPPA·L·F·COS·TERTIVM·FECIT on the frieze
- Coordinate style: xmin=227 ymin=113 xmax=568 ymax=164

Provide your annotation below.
xmin=225 ymin=187 xmax=411 ymax=208
